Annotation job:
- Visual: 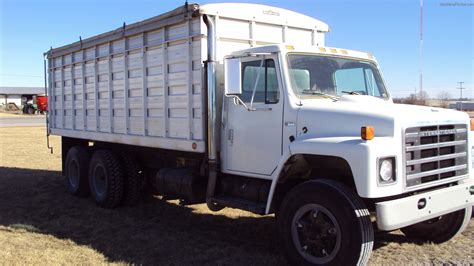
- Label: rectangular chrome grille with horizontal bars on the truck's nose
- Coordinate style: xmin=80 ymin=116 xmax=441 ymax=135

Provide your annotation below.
xmin=405 ymin=124 xmax=468 ymax=188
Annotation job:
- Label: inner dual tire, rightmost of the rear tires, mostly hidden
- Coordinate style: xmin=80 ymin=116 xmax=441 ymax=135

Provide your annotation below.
xmin=120 ymin=152 xmax=145 ymax=206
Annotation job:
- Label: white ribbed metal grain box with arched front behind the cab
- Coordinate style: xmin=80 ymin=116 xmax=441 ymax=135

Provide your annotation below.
xmin=48 ymin=4 xmax=322 ymax=153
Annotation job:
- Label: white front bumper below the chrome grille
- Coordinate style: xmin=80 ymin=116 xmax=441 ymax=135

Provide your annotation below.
xmin=375 ymin=181 xmax=474 ymax=231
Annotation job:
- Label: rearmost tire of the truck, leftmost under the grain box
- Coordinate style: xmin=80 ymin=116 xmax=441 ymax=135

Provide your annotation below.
xmin=64 ymin=146 xmax=90 ymax=197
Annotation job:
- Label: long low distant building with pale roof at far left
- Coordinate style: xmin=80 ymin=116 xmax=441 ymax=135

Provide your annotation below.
xmin=0 ymin=87 xmax=44 ymax=110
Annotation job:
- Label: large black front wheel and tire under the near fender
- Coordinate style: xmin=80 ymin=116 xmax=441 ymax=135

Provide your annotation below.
xmin=277 ymin=179 xmax=374 ymax=265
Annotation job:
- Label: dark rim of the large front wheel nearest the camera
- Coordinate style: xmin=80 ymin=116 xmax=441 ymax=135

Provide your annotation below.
xmin=291 ymin=204 xmax=341 ymax=264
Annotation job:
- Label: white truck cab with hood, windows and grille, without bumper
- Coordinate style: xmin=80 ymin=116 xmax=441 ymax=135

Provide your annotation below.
xmin=221 ymin=45 xmax=471 ymax=202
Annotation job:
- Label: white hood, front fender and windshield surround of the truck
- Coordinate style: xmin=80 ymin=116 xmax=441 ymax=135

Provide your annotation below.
xmin=262 ymin=45 xmax=472 ymax=213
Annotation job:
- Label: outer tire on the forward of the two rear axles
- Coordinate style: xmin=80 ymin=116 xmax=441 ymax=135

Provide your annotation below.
xmin=89 ymin=150 xmax=124 ymax=208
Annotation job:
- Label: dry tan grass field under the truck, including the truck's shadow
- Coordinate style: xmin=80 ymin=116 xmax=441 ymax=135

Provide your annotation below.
xmin=0 ymin=127 xmax=474 ymax=265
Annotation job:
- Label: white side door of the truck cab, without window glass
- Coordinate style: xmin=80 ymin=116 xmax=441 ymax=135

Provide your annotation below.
xmin=221 ymin=56 xmax=284 ymax=176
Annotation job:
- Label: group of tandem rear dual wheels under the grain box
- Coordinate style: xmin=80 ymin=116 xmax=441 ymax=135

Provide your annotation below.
xmin=64 ymin=146 xmax=145 ymax=208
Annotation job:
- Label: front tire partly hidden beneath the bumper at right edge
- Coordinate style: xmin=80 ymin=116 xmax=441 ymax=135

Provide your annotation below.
xmin=400 ymin=207 xmax=472 ymax=244
